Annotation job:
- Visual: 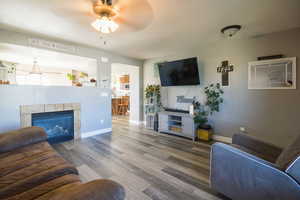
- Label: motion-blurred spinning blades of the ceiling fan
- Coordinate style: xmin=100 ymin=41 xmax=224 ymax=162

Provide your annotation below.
xmin=53 ymin=0 xmax=153 ymax=32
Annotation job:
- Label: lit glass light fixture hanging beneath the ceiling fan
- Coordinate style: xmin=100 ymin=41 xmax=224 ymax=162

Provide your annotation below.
xmin=91 ymin=16 xmax=119 ymax=34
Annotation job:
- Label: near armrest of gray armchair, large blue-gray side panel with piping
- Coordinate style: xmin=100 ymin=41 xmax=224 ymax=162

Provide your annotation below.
xmin=210 ymin=143 xmax=300 ymax=200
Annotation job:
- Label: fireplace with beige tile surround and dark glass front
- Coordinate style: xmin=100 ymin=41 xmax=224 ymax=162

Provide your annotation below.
xmin=20 ymin=103 xmax=81 ymax=143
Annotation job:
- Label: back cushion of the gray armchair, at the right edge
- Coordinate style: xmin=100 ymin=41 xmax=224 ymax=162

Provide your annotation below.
xmin=276 ymin=135 xmax=300 ymax=169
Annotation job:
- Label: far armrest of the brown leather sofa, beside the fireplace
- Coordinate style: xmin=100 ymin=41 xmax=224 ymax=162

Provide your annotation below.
xmin=0 ymin=127 xmax=47 ymax=153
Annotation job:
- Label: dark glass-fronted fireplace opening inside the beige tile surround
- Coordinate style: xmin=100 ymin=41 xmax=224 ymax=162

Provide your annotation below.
xmin=32 ymin=111 xmax=74 ymax=144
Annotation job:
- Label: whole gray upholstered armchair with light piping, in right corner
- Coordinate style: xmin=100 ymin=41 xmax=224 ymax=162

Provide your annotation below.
xmin=210 ymin=134 xmax=300 ymax=200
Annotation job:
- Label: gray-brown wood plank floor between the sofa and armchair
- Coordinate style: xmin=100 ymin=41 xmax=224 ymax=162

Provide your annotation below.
xmin=54 ymin=118 xmax=229 ymax=200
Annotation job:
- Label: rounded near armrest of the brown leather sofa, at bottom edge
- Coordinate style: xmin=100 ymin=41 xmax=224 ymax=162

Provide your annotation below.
xmin=47 ymin=179 xmax=125 ymax=200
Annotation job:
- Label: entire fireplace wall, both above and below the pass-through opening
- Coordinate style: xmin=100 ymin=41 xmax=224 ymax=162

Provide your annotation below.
xmin=0 ymin=30 xmax=143 ymax=132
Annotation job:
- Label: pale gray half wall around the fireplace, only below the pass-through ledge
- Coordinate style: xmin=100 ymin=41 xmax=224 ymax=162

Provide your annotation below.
xmin=0 ymin=85 xmax=111 ymax=133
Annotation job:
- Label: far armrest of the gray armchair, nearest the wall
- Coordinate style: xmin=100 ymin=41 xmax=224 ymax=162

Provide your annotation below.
xmin=232 ymin=133 xmax=282 ymax=162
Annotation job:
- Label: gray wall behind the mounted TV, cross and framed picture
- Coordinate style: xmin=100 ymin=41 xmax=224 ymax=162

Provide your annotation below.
xmin=144 ymin=29 xmax=300 ymax=146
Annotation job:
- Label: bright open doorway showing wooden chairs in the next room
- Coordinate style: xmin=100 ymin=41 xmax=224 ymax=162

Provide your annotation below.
xmin=111 ymin=63 xmax=140 ymax=123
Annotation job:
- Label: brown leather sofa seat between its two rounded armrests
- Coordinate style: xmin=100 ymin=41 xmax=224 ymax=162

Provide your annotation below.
xmin=0 ymin=142 xmax=78 ymax=199
